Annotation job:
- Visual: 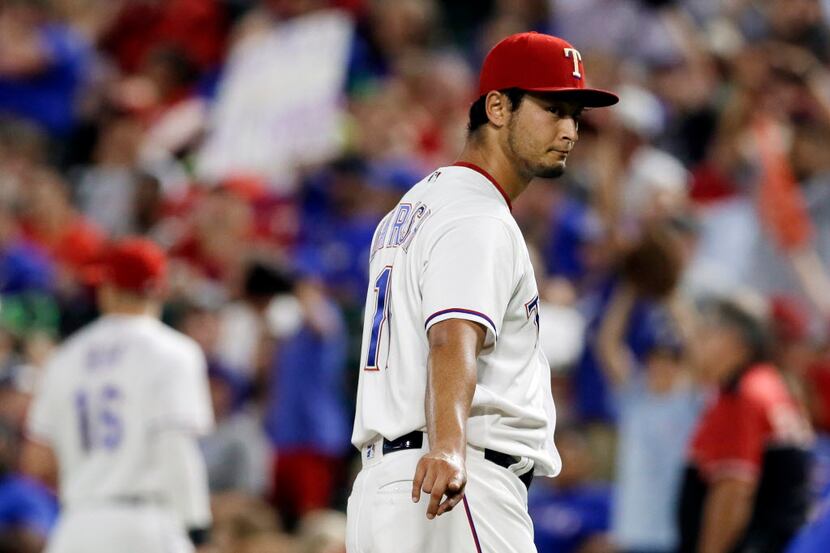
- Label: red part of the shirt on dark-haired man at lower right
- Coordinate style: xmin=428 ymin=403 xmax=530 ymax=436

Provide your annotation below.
xmin=690 ymin=365 xmax=810 ymax=482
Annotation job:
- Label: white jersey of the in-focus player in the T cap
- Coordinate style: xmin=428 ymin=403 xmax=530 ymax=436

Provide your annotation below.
xmin=352 ymin=164 xmax=561 ymax=476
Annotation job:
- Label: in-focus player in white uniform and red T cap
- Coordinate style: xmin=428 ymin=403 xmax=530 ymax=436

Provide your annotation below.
xmin=347 ymin=33 xmax=617 ymax=553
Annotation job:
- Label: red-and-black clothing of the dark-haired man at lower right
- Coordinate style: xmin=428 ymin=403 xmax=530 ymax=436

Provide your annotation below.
xmin=678 ymin=364 xmax=811 ymax=553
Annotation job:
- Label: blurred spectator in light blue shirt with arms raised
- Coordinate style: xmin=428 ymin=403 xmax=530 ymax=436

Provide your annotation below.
xmin=597 ymin=284 xmax=702 ymax=553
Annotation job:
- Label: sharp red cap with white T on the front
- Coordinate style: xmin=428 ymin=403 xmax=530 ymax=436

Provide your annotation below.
xmin=478 ymin=32 xmax=619 ymax=107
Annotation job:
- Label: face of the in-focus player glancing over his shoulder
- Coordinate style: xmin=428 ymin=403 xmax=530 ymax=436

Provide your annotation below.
xmin=507 ymin=93 xmax=582 ymax=178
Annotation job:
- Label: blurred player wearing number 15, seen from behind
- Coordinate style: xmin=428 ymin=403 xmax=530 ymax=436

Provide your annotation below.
xmin=23 ymin=238 xmax=213 ymax=553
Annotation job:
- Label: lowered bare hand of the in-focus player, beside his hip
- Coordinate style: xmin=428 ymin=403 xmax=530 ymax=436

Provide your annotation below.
xmin=412 ymin=450 xmax=467 ymax=520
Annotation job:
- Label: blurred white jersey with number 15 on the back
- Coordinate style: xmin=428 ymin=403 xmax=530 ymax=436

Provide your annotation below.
xmin=28 ymin=315 xmax=213 ymax=509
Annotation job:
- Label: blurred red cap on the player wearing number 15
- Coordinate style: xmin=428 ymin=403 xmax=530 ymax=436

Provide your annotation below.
xmin=95 ymin=237 xmax=167 ymax=295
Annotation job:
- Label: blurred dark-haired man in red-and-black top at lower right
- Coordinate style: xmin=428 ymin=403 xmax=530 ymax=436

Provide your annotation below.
xmin=680 ymin=302 xmax=811 ymax=553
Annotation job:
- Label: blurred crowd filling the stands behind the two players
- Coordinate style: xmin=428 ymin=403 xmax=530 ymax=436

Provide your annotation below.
xmin=0 ymin=0 xmax=830 ymax=553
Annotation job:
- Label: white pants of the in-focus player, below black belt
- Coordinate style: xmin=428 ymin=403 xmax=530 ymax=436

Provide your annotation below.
xmin=346 ymin=449 xmax=536 ymax=553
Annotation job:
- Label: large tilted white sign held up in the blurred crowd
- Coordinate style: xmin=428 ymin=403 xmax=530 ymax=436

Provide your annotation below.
xmin=196 ymin=10 xmax=354 ymax=193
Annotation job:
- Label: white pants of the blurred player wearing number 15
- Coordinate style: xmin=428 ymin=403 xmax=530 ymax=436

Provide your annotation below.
xmin=46 ymin=503 xmax=194 ymax=553
